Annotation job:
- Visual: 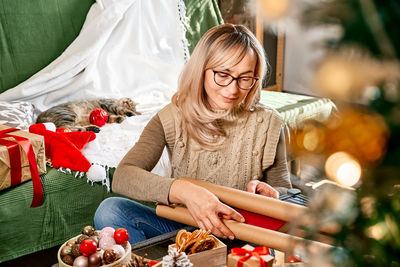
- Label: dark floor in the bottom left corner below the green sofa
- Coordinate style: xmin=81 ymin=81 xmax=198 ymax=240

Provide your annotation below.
xmin=0 ymin=246 xmax=60 ymax=267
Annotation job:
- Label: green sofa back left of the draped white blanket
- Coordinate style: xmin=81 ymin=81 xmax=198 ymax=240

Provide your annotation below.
xmin=0 ymin=0 xmax=95 ymax=93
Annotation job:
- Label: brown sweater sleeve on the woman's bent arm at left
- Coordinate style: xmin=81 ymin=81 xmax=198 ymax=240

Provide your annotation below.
xmin=112 ymin=115 xmax=174 ymax=204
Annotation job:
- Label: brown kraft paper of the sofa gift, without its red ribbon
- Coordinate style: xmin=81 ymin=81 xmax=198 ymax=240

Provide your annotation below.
xmin=0 ymin=125 xmax=46 ymax=190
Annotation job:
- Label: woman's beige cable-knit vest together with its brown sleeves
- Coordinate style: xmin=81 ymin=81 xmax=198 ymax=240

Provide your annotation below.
xmin=112 ymin=104 xmax=291 ymax=204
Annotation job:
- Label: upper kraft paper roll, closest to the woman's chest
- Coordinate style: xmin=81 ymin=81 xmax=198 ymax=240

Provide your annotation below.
xmin=179 ymin=177 xmax=337 ymax=234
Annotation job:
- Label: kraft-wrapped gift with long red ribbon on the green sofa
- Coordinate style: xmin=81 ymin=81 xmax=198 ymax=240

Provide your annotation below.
xmin=0 ymin=125 xmax=46 ymax=207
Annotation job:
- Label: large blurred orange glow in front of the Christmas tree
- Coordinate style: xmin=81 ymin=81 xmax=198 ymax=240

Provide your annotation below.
xmin=290 ymin=107 xmax=389 ymax=168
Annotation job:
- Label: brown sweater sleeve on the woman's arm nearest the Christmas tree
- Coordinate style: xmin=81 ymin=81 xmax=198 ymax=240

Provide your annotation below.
xmin=263 ymin=127 xmax=292 ymax=194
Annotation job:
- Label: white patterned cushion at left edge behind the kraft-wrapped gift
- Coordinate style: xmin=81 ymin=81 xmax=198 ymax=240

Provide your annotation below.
xmin=0 ymin=101 xmax=35 ymax=130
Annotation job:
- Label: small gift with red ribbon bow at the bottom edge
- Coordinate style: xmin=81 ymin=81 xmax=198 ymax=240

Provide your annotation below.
xmin=228 ymin=245 xmax=274 ymax=267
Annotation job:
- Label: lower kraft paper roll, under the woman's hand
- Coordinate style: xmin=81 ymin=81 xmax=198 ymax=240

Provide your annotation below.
xmin=156 ymin=204 xmax=332 ymax=252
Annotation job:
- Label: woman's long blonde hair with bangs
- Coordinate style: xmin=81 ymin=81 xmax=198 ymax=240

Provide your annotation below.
xmin=172 ymin=24 xmax=266 ymax=150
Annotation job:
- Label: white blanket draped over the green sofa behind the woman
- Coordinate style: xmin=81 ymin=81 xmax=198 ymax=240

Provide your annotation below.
xmin=0 ymin=0 xmax=189 ymax=175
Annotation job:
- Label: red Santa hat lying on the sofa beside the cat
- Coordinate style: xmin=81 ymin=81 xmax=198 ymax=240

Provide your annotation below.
xmin=29 ymin=123 xmax=96 ymax=172
